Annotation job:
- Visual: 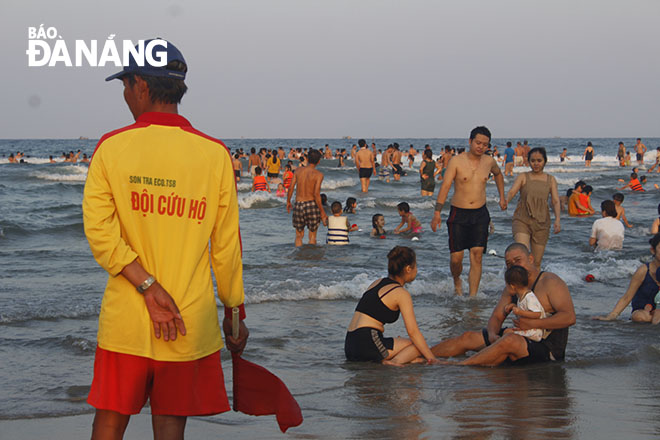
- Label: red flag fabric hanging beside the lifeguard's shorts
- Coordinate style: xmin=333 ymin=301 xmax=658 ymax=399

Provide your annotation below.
xmin=231 ymin=353 xmax=303 ymax=432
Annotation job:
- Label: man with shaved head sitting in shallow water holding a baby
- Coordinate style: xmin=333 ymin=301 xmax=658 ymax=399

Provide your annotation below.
xmin=390 ymin=243 xmax=575 ymax=366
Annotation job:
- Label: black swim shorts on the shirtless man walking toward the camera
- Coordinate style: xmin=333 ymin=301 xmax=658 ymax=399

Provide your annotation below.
xmin=447 ymin=205 xmax=490 ymax=252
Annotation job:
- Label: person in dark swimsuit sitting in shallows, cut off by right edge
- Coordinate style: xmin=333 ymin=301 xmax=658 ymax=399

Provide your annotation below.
xmin=593 ymin=234 xmax=660 ymax=324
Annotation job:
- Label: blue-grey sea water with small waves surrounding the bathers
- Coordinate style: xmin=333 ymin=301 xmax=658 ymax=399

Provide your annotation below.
xmin=0 ymin=138 xmax=660 ymax=439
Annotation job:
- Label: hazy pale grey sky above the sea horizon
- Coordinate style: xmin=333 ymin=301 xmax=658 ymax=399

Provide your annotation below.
xmin=0 ymin=0 xmax=660 ymax=139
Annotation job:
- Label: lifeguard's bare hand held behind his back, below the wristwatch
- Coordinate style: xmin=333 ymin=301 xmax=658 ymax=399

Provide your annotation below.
xmin=144 ymin=282 xmax=186 ymax=341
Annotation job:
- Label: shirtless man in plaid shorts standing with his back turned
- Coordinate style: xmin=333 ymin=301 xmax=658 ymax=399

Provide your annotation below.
xmin=286 ymin=148 xmax=328 ymax=247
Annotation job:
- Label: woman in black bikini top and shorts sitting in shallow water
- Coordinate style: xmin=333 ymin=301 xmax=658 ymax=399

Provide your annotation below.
xmin=344 ymin=246 xmax=437 ymax=365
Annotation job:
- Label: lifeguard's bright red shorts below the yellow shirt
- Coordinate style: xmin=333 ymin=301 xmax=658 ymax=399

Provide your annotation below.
xmin=87 ymin=346 xmax=230 ymax=416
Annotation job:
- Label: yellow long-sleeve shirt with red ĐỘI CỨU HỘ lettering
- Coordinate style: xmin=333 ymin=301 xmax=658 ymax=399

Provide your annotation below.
xmin=83 ymin=112 xmax=244 ymax=361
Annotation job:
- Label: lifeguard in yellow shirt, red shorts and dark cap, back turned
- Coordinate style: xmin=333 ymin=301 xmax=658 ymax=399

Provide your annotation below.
xmin=82 ymin=41 xmax=249 ymax=439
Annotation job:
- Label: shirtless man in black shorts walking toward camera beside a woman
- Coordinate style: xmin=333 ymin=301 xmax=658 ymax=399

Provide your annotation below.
xmin=431 ymin=127 xmax=506 ymax=296
